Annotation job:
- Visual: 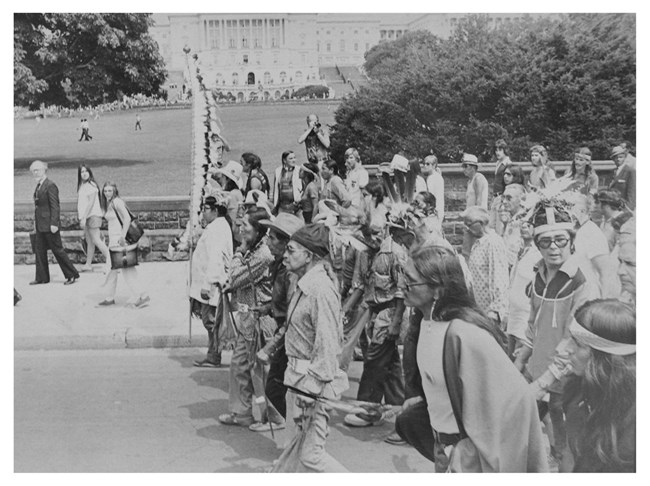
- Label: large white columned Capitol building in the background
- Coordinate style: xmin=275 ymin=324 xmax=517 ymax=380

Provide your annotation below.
xmin=150 ymin=13 xmax=539 ymax=102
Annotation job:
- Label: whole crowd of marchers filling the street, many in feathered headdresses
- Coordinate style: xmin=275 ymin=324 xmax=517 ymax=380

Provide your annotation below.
xmin=182 ymin=115 xmax=636 ymax=472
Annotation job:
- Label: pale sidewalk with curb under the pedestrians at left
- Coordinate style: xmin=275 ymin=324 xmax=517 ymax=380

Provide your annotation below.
xmin=14 ymin=261 xmax=208 ymax=350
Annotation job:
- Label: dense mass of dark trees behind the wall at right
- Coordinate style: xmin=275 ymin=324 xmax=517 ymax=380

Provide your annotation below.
xmin=331 ymin=14 xmax=636 ymax=163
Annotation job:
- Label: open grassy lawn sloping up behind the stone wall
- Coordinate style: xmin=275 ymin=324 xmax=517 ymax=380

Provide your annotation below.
xmin=14 ymin=102 xmax=337 ymax=201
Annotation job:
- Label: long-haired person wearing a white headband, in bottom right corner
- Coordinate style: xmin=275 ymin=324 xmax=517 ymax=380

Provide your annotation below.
xmin=563 ymin=299 xmax=636 ymax=472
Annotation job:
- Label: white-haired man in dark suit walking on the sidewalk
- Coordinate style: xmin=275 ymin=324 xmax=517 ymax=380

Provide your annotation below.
xmin=29 ymin=160 xmax=79 ymax=285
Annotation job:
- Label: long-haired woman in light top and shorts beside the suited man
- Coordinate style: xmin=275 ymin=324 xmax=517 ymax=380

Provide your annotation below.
xmin=77 ymin=164 xmax=111 ymax=272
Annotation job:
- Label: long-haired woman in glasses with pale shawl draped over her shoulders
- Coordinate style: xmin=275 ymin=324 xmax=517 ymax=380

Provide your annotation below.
xmin=395 ymin=246 xmax=548 ymax=472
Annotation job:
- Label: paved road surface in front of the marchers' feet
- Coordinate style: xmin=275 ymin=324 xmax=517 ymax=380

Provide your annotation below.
xmin=14 ymin=348 xmax=433 ymax=472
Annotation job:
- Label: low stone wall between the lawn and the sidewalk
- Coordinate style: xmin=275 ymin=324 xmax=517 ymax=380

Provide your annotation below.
xmin=14 ymin=161 xmax=614 ymax=264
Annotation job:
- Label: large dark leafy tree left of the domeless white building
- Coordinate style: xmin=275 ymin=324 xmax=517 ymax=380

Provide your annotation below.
xmin=14 ymin=13 xmax=166 ymax=108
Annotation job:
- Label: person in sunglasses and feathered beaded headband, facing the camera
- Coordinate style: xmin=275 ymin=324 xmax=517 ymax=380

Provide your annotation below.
xmin=515 ymin=202 xmax=599 ymax=462
